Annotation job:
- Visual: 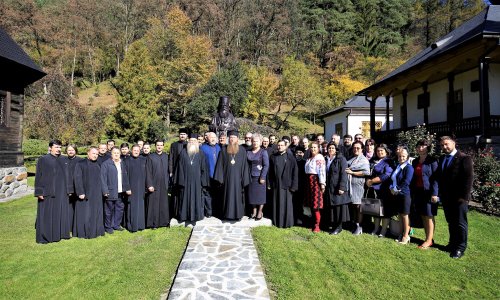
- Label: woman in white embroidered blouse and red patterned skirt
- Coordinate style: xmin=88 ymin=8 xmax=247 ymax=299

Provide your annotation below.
xmin=305 ymin=142 xmax=326 ymax=232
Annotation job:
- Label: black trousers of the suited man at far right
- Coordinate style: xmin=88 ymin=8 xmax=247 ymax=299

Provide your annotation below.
xmin=443 ymin=200 xmax=469 ymax=252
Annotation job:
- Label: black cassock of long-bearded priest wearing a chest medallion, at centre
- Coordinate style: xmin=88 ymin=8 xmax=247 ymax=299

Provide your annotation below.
xmin=214 ymin=146 xmax=250 ymax=220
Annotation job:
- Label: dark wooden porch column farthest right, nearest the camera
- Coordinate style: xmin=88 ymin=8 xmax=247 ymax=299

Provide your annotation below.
xmin=479 ymin=57 xmax=491 ymax=138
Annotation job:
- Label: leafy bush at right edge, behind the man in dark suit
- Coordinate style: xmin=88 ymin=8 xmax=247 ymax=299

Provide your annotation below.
xmin=470 ymin=148 xmax=500 ymax=214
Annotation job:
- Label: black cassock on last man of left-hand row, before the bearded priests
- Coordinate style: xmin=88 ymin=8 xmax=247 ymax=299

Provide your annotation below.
xmin=146 ymin=152 xmax=170 ymax=228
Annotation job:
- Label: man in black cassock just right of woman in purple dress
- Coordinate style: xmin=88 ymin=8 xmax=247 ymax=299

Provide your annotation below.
xmin=268 ymin=141 xmax=299 ymax=228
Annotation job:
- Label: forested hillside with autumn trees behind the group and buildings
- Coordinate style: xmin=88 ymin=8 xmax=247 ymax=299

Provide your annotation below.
xmin=0 ymin=0 xmax=485 ymax=143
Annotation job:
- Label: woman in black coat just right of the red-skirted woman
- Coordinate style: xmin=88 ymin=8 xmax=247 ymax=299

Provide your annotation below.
xmin=325 ymin=142 xmax=351 ymax=235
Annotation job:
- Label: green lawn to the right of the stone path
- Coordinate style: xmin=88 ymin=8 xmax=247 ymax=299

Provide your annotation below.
xmin=253 ymin=210 xmax=500 ymax=299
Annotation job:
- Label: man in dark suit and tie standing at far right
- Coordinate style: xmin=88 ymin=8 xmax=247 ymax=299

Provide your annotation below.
xmin=437 ymin=136 xmax=474 ymax=258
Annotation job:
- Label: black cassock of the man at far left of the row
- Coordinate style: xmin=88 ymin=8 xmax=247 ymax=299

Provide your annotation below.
xmin=35 ymin=154 xmax=71 ymax=244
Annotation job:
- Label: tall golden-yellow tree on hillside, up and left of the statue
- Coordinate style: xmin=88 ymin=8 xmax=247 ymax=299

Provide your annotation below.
xmin=145 ymin=7 xmax=216 ymax=127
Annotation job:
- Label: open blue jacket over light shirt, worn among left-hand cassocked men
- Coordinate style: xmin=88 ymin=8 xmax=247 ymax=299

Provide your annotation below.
xmin=101 ymin=159 xmax=130 ymax=200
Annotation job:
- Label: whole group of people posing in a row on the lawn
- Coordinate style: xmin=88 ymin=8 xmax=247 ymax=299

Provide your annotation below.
xmin=35 ymin=129 xmax=473 ymax=258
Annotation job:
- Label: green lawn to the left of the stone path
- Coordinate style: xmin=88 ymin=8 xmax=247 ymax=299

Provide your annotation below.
xmin=0 ymin=191 xmax=191 ymax=299
